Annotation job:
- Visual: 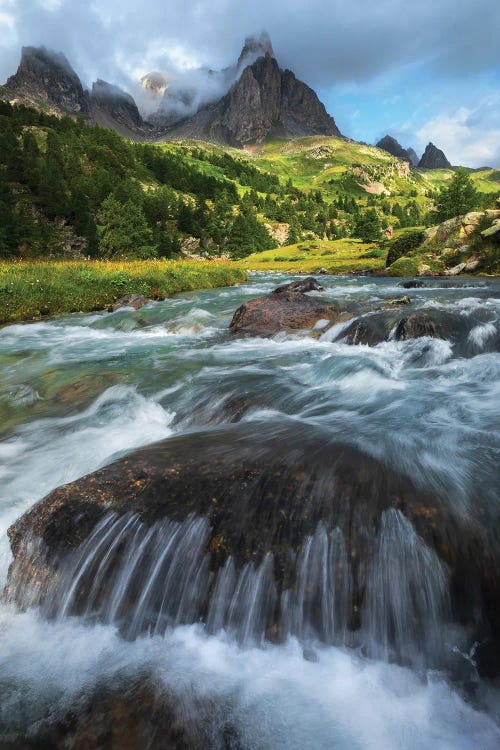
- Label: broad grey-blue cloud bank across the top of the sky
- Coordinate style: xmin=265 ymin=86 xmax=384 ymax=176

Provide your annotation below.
xmin=0 ymin=0 xmax=500 ymax=86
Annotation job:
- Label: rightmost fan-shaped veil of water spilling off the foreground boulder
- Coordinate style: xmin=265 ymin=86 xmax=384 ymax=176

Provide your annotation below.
xmin=363 ymin=508 xmax=449 ymax=663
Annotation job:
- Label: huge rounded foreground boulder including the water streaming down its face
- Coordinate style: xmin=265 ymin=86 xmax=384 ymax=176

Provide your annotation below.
xmin=5 ymin=421 xmax=500 ymax=672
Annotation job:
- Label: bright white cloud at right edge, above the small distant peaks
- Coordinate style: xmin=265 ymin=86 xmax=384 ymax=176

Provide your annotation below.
xmin=416 ymin=94 xmax=500 ymax=167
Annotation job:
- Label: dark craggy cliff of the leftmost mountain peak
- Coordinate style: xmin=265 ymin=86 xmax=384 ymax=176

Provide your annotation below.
xmin=6 ymin=47 xmax=89 ymax=115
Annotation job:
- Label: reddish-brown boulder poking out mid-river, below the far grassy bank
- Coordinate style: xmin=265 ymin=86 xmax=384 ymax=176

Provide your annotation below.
xmin=230 ymin=277 xmax=341 ymax=336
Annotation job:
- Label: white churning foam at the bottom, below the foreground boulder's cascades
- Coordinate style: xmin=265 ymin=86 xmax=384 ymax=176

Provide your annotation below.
xmin=0 ymin=608 xmax=500 ymax=750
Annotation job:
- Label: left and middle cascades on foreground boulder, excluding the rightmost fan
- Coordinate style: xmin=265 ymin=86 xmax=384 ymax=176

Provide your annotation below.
xmin=20 ymin=513 xmax=351 ymax=645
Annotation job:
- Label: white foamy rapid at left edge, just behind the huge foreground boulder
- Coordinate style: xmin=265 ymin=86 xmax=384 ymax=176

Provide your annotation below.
xmin=0 ymin=386 xmax=174 ymax=584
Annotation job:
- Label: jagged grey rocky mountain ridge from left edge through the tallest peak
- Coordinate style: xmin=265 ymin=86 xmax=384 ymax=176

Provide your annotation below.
xmin=3 ymin=35 xmax=340 ymax=147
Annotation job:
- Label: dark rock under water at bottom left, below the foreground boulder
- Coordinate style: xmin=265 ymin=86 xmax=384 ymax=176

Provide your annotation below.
xmin=20 ymin=673 xmax=237 ymax=750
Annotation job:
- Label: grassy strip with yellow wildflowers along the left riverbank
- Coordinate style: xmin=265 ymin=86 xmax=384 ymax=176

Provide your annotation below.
xmin=0 ymin=260 xmax=247 ymax=323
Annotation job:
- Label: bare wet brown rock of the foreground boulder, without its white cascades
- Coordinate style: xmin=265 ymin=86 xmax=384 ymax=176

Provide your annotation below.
xmin=5 ymin=423 xmax=500 ymax=673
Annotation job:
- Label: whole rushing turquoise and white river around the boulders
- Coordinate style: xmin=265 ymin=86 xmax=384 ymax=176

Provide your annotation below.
xmin=0 ymin=274 xmax=500 ymax=750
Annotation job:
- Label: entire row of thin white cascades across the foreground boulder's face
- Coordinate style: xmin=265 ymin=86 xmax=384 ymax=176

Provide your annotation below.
xmin=10 ymin=508 xmax=450 ymax=665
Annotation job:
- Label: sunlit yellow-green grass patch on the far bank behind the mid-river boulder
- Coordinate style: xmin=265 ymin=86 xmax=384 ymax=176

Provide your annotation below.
xmin=239 ymin=239 xmax=387 ymax=273
